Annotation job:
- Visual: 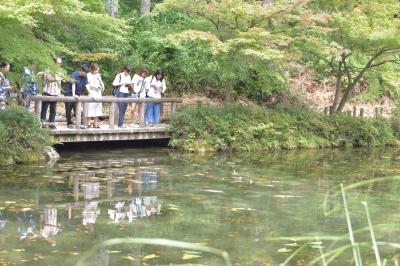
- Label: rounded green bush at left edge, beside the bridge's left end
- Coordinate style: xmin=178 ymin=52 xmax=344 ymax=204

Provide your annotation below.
xmin=0 ymin=105 xmax=52 ymax=165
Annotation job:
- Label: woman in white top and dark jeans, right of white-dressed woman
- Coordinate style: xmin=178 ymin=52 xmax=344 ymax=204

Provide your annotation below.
xmin=113 ymin=65 xmax=132 ymax=127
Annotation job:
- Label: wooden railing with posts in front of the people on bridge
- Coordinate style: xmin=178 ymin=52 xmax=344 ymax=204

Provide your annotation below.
xmin=28 ymin=96 xmax=182 ymax=129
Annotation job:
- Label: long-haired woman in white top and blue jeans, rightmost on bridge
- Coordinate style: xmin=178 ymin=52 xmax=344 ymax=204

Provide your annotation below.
xmin=146 ymin=69 xmax=167 ymax=125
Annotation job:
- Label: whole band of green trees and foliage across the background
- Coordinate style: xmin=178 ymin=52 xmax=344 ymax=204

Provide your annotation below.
xmin=0 ymin=0 xmax=400 ymax=103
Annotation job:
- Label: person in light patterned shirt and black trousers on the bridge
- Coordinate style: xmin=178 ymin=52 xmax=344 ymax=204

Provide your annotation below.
xmin=37 ymin=56 xmax=63 ymax=129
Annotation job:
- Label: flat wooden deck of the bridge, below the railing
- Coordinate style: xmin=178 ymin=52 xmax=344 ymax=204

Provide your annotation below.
xmin=51 ymin=124 xmax=169 ymax=143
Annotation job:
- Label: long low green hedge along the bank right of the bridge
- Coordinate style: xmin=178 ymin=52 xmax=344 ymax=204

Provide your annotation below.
xmin=170 ymin=105 xmax=400 ymax=151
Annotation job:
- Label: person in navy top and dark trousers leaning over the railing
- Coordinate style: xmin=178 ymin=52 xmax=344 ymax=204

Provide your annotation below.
xmin=64 ymin=64 xmax=90 ymax=128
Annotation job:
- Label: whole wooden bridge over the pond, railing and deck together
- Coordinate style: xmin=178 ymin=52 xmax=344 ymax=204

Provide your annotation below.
xmin=29 ymin=96 xmax=182 ymax=143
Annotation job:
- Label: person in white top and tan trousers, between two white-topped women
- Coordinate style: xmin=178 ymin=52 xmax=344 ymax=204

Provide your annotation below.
xmin=131 ymin=67 xmax=150 ymax=124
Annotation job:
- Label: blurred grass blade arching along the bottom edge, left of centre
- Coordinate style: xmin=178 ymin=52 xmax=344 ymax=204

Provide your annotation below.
xmin=76 ymin=238 xmax=232 ymax=266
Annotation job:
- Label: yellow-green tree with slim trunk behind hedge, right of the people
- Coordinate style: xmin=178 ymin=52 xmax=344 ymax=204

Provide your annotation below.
xmin=156 ymin=0 xmax=305 ymax=101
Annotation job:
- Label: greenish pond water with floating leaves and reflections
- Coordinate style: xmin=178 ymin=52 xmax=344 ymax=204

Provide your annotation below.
xmin=0 ymin=148 xmax=400 ymax=265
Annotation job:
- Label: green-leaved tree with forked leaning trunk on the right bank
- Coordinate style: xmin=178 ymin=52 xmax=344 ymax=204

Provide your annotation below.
xmin=296 ymin=0 xmax=400 ymax=113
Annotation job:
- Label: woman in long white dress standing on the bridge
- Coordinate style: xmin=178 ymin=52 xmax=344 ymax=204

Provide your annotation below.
xmin=86 ymin=64 xmax=104 ymax=128
